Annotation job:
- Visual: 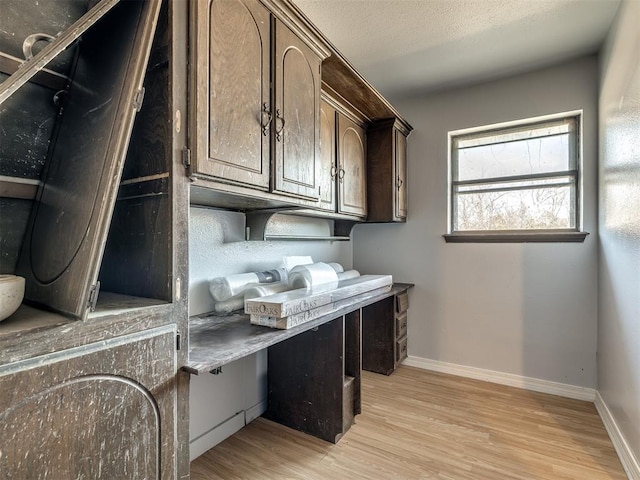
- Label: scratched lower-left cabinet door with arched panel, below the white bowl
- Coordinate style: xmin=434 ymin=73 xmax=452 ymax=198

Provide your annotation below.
xmin=0 ymin=325 xmax=177 ymax=479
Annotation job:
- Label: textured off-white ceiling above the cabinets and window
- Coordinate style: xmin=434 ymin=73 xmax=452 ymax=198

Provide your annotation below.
xmin=293 ymin=0 xmax=619 ymax=97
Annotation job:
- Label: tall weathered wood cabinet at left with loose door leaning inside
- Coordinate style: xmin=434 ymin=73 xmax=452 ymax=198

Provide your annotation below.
xmin=0 ymin=0 xmax=189 ymax=478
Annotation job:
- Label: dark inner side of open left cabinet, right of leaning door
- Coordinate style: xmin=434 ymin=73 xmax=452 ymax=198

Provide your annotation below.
xmin=99 ymin=34 xmax=173 ymax=301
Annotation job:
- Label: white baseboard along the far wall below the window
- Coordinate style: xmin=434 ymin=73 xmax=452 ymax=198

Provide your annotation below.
xmin=402 ymin=356 xmax=596 ymax=402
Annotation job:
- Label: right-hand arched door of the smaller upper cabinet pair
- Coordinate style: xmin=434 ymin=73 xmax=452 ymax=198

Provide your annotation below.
xmin=338 ymin=113 xmax=367 ymax=217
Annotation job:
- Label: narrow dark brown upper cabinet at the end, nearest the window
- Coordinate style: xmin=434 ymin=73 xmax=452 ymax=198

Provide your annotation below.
xmin=367 ymin=118 xmax=410 ymax=222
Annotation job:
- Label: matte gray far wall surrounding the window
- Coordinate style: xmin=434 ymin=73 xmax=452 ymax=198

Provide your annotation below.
xmin=353 ymin=56 xmax=598 ymax=388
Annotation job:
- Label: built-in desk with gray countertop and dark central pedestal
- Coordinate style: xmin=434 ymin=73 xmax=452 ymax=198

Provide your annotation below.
xmin=184 ymin=283 xmax=412 ymax=443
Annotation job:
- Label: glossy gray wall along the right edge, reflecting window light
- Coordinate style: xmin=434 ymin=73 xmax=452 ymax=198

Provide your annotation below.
xmin=598 ymin=1 xmax=640 ymax=462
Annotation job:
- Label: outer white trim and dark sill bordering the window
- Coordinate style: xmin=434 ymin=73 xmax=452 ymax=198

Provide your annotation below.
xmin=443 ymin=110 xmax=589 ymax=243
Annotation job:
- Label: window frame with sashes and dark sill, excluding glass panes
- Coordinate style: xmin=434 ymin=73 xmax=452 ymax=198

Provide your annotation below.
xmin=443 ymin=110 xmax=588 ymax=243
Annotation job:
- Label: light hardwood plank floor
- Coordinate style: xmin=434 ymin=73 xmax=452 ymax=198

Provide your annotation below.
xmin=191 ymin=366 xmax=627 ymax=480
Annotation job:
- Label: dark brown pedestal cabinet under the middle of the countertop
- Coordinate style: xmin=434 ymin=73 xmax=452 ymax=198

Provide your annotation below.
xmin=264 ymin=310 xmax=361 ymax=443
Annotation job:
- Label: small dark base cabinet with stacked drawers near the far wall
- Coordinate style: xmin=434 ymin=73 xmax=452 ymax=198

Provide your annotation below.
xmin=362 ymin=284 xmax=410 ymax=375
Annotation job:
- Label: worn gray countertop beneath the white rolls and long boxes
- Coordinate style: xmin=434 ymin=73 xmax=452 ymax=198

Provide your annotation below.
xmin=183 ymin=283 xmax=413 ymax=375
